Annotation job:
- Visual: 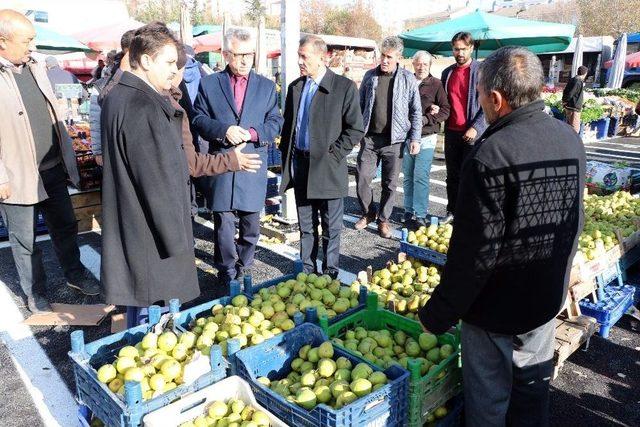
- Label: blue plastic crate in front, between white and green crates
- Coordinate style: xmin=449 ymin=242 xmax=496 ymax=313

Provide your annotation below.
xmin=236 ymin=323 xmax=409 ymax=427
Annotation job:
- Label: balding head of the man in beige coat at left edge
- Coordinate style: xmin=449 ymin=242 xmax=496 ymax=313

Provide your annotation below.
xmin=0 ymin=9 xmax=36 ymax=65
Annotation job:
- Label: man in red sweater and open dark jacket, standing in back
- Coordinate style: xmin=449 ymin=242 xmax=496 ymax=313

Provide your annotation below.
xmin=441 ymin=32 xmax=487 ymax=222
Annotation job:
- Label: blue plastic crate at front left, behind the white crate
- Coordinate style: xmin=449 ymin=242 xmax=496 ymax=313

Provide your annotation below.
xmin=69 ymin=290 xmax=245 ymax=427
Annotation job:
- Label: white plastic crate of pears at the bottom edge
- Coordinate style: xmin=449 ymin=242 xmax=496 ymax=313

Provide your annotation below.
xmin=144 ymin=376 xmax=287 ymax=427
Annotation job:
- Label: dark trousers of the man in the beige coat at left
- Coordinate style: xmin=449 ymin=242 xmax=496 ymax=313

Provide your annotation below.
xmin=0 ymin=165 xmax=84 ymax=296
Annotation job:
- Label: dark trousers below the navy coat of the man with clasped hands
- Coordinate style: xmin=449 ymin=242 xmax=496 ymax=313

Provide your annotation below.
xmin=213 ymin=211 xmax=260 ymax=279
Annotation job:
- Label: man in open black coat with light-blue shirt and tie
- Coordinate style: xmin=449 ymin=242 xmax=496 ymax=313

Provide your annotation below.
xmin=280 ymin=35 xmax=364 ymax=278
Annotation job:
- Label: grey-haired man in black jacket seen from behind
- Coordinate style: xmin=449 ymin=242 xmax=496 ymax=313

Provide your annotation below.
xmin=418 ymin=47 xmax=585 ymax=426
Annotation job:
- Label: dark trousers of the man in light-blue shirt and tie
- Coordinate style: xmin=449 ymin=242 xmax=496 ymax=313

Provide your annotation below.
xmin=293 ymin=155 xmax=344 ymax=277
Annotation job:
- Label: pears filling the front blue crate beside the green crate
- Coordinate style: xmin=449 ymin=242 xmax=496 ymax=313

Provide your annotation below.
xmin=257 ymin=341 xmax=387 ymax=410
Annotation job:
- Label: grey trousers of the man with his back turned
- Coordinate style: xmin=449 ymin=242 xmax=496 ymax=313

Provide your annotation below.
xmin=461 ymin=319 xmax=555 ymax=427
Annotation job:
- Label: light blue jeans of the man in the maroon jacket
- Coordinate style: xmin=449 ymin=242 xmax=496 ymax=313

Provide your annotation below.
xmin=402 ymin=134 xmax=437 ymax=218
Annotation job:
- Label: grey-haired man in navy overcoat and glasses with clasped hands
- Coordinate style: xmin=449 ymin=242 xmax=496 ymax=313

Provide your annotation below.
xmin=193 ymin=28 xmax=283 ymax=283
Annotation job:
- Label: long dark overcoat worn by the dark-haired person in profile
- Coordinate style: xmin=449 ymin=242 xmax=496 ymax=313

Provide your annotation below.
xmin=101 ymin=72 xmax=200 ymax=307
